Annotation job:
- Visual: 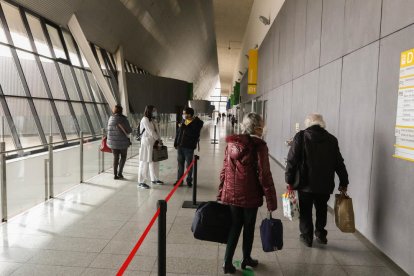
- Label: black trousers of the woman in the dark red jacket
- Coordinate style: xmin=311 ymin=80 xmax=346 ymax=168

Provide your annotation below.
xmin=224 ymin=206 xmax=258 ymax=263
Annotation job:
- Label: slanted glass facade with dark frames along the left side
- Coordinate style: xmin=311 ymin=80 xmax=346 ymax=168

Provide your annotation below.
xmin=0 ymin=0 xmax=118 ymax=154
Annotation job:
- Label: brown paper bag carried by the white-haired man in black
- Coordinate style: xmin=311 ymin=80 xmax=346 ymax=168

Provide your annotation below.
xmin=334 ymin=193 xmax=355 ymax=233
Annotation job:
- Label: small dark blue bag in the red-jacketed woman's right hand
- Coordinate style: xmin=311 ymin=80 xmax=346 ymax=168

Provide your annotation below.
xmin=260 ymin=213 xmax=283 ymax=252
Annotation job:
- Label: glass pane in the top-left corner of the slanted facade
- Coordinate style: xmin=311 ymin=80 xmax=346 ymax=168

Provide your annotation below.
xmin=1 ymin=1 xmax=32 ymax=51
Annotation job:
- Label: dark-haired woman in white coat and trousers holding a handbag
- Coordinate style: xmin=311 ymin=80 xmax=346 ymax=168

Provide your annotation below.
xmin=138 ymin=105 xmax=164 ymax=189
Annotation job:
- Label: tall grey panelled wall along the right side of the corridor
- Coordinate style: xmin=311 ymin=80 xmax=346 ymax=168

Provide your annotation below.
xmin=241 ymin=0 xmax=414 ymax=274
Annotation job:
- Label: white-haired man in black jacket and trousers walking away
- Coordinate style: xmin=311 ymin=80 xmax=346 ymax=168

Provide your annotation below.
xmin=285 ymin=114 xmax=349 ymax=247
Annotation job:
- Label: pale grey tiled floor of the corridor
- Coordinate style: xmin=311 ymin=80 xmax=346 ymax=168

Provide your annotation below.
xmin=0 ymin=119 xmax=401 ymax=276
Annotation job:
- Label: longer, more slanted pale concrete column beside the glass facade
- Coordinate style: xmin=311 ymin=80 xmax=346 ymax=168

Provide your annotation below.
xmin=68 ymin=14 xmax=116 ymax=108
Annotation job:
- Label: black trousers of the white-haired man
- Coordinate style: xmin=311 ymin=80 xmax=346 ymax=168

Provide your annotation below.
xmin=299 ymin=191 xmax=330 ymax=239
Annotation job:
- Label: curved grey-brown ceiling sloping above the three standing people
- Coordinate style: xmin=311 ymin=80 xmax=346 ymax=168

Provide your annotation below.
xmin=15 ymin=0 xmax=220 ymax=99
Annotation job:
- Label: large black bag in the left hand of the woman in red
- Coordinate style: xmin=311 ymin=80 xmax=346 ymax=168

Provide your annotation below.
xmin=191 ymin=201 xmax=231 ymax=243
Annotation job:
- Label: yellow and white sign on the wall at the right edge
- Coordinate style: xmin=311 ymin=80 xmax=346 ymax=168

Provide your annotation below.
xmin=394 ymin=49 xmax=414 ymax=162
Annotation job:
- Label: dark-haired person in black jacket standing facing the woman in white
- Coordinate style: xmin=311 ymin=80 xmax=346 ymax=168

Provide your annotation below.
xmin=174 ymin=107 xmax=204 ymax=187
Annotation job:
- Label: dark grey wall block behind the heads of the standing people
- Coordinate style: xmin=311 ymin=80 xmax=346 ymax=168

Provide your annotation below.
xmin=126 ymin=73 xmax=190 ymax=113
